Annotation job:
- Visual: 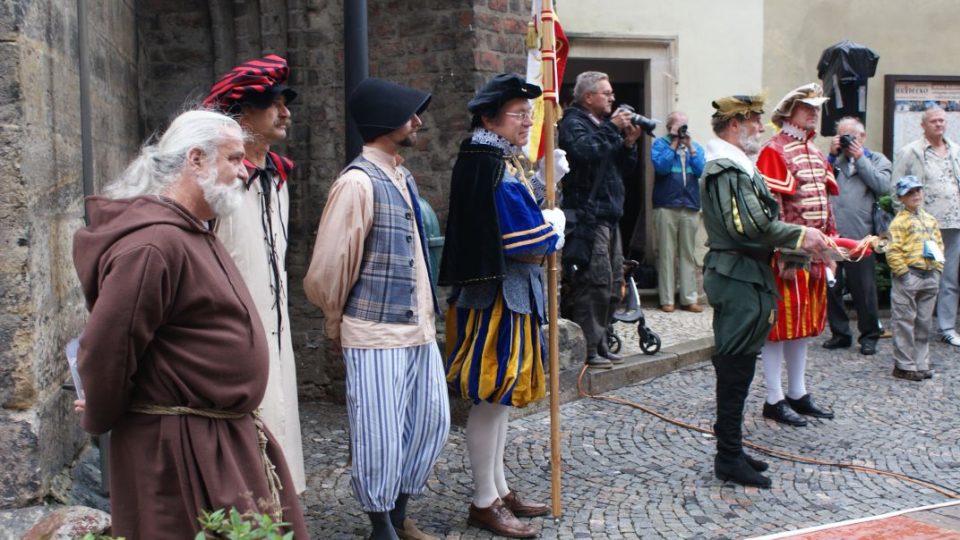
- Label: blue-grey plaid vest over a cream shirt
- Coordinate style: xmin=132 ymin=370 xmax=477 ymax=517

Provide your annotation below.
xmin=343 ymin=156 xmax=437 ymax=324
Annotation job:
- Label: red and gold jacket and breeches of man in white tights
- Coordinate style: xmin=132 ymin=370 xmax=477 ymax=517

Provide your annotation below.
xmin=757 ymin=127 xmax=840 ymax=341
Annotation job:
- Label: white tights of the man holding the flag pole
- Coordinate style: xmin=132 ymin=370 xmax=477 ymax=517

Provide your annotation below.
xmin=467 ymin=401 xmax=510 ymax=508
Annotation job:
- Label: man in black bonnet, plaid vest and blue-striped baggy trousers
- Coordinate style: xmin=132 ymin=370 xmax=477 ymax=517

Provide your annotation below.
xmin=303 ymin=78 xmax=450 ymax=539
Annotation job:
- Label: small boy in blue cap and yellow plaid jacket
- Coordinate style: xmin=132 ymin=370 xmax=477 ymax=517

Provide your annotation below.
xmin=887 ymin=176 xmax=943 ymax=381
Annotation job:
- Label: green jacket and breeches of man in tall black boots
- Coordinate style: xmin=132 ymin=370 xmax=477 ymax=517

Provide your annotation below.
xmin=700 ymin=158 xmax=803 ymax=355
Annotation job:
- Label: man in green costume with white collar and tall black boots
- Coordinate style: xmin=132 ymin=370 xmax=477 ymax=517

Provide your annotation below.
xmin=700 ymin=96 xmax=827 ymax=488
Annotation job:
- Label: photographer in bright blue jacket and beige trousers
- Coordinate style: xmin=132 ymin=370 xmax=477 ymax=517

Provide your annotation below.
xmin=650 ymin=111 xmax=704 ymax=313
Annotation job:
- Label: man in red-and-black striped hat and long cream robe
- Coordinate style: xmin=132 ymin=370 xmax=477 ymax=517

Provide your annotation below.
xmin=203 ymin=54 xmax=306 ymax=494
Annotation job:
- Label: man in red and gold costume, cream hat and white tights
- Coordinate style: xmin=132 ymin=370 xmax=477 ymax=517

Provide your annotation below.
xmin=757 ymin=83 xmax=839 ymax=426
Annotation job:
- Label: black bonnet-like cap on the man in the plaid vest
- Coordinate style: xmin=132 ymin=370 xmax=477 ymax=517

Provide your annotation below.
xmin=348 ymin=77 xmax=433 ymax=142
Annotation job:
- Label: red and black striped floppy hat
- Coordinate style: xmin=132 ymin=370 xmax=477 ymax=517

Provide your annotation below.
xmin=203 ymin=54 xmax=297 ymax=111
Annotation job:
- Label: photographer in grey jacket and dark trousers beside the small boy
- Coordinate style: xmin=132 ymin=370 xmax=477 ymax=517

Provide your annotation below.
xmin=823 ymin=116 xmax=893 ymax=355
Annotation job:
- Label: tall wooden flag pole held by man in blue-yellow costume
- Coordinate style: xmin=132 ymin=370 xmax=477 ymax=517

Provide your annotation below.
xmin=540 ymin=0 xmax=561 ymax=519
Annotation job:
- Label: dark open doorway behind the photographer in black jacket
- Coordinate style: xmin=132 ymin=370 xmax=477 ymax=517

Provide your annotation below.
xmin=560 ymin=58 xmax=652 ymax=261
